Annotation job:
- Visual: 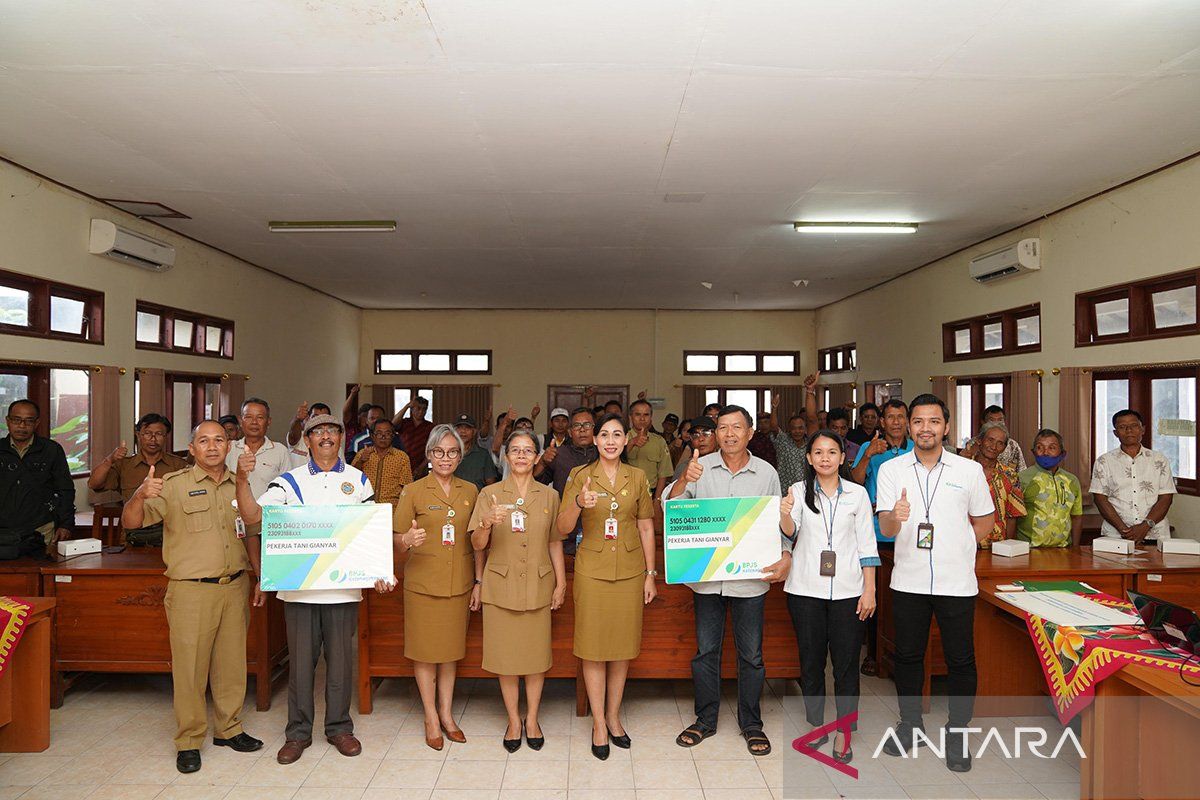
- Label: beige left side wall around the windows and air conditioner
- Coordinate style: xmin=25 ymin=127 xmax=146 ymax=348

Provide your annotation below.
xmin=0 ymin=162 xmax=361 ymax=507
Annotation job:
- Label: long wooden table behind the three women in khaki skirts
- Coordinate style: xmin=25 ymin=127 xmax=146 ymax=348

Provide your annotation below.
xmin=359 ymin=553 xmax=800 ymax=716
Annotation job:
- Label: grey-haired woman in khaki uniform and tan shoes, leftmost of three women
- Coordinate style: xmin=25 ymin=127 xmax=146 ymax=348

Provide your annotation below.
xmin=392 ymin=425 xmax=484 ymax=750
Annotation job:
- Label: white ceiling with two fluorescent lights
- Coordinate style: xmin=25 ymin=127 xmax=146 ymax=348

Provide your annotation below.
xmin=0 ymin=0 xmax=1200 ymax=308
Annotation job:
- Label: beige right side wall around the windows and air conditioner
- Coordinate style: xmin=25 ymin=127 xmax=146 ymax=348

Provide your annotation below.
xmin=817 ymin=158 xmax=1200 ymax=537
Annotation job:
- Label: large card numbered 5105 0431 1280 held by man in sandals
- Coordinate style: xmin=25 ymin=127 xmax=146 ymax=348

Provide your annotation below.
xmin=664 ymin=497 xmax=782 ymax=583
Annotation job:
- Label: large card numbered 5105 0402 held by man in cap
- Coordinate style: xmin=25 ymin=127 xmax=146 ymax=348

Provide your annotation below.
xmin=262 ymin=503 xmax=394 ymax=591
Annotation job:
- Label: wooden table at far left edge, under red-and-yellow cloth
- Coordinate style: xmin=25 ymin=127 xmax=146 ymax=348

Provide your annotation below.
xmin=0 ymin=597 xmax=55 ymax=753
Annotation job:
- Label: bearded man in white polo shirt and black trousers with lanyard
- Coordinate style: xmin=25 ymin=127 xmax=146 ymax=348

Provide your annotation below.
xmin=875 ymin=395 xmax=996 ymax=772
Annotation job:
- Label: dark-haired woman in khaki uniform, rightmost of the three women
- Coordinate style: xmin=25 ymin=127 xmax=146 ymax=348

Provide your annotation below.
xmin=558 ymin=414 xmax=658 ymax=760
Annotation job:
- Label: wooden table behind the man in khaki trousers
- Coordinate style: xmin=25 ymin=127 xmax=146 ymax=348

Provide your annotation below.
xmin=42 ymin=548 xmax=287 ymax=711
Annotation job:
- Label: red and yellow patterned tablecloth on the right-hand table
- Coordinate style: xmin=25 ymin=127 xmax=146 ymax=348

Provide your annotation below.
xmin=1014 ymin=593 xmax=1200 ymax=724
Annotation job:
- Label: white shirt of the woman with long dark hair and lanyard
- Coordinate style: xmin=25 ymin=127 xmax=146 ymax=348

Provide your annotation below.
xmin=784 ymin=481 xmax=880 ymax=600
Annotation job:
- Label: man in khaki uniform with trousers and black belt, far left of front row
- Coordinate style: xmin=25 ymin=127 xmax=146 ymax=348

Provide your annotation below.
xmin=121 ymin=421 xmax=263 ymax=772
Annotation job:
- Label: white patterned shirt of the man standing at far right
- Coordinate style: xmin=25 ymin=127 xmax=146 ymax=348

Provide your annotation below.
xmin=1090 ymin=447 xmax=1175 ymax=539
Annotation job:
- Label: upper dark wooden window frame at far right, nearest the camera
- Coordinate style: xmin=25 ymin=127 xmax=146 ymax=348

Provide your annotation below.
xmin=1075 ymin=267 xmax=1200 ymax=345
